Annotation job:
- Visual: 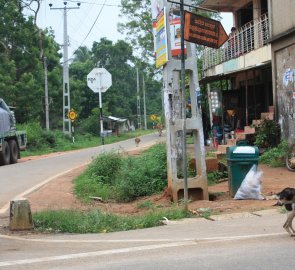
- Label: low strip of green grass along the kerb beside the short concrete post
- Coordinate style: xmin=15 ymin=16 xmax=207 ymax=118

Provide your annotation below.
xmin=33 ymin=208 xmax=191 ymax=233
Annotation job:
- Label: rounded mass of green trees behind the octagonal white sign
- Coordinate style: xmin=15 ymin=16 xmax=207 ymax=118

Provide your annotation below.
xmin=70 ymin=38 xmax=161 ymax=132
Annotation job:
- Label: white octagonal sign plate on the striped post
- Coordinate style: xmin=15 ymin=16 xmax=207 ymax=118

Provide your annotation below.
xmin=87 ymin=68 xmax=112 ymax=93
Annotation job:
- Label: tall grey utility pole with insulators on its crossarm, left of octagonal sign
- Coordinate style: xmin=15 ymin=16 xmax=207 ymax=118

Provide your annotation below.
xmin=49 ymin=2 xmax=81 ymax=135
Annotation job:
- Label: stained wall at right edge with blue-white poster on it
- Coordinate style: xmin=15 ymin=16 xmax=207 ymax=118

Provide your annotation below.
xmin=269 ymin=0 xmax=295 ymax=143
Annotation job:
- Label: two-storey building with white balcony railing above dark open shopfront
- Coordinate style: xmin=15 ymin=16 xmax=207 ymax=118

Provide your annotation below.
xmin=200 ymin=0 xmax=274 ymax=148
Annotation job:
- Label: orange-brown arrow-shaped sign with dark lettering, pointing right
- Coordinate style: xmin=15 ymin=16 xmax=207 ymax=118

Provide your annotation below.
xmin=184 ymin=11 xmax=228 ymax=49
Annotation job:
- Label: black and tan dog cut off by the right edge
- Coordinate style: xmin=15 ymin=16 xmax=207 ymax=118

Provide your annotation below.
xmin=277 ymin=187 xmax=295 ymax=236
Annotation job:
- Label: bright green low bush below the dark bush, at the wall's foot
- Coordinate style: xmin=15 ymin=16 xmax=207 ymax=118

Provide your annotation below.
xmin=260 ymin=140 xmax=289 ymax=167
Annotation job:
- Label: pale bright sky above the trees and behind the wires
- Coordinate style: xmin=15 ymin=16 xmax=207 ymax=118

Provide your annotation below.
xmin=37 ymin=0 xmax=233 ymax=59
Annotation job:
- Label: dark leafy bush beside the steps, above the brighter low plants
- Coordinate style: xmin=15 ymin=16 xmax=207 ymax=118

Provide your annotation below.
xmin=254 ymin=119 xmax=281 ymax=148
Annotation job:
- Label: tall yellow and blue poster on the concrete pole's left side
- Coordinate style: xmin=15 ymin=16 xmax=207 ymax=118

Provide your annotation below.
xmin=156 ymin=8 xmax=168 ymax=68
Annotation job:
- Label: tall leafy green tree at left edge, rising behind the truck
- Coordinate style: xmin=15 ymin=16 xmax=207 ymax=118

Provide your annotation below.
xmin=0 ymin=0 xmax=60 ymax=123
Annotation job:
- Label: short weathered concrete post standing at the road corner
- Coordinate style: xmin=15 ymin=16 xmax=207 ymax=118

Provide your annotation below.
xmin=9 ymin=198 xmax=34 ymax=231
